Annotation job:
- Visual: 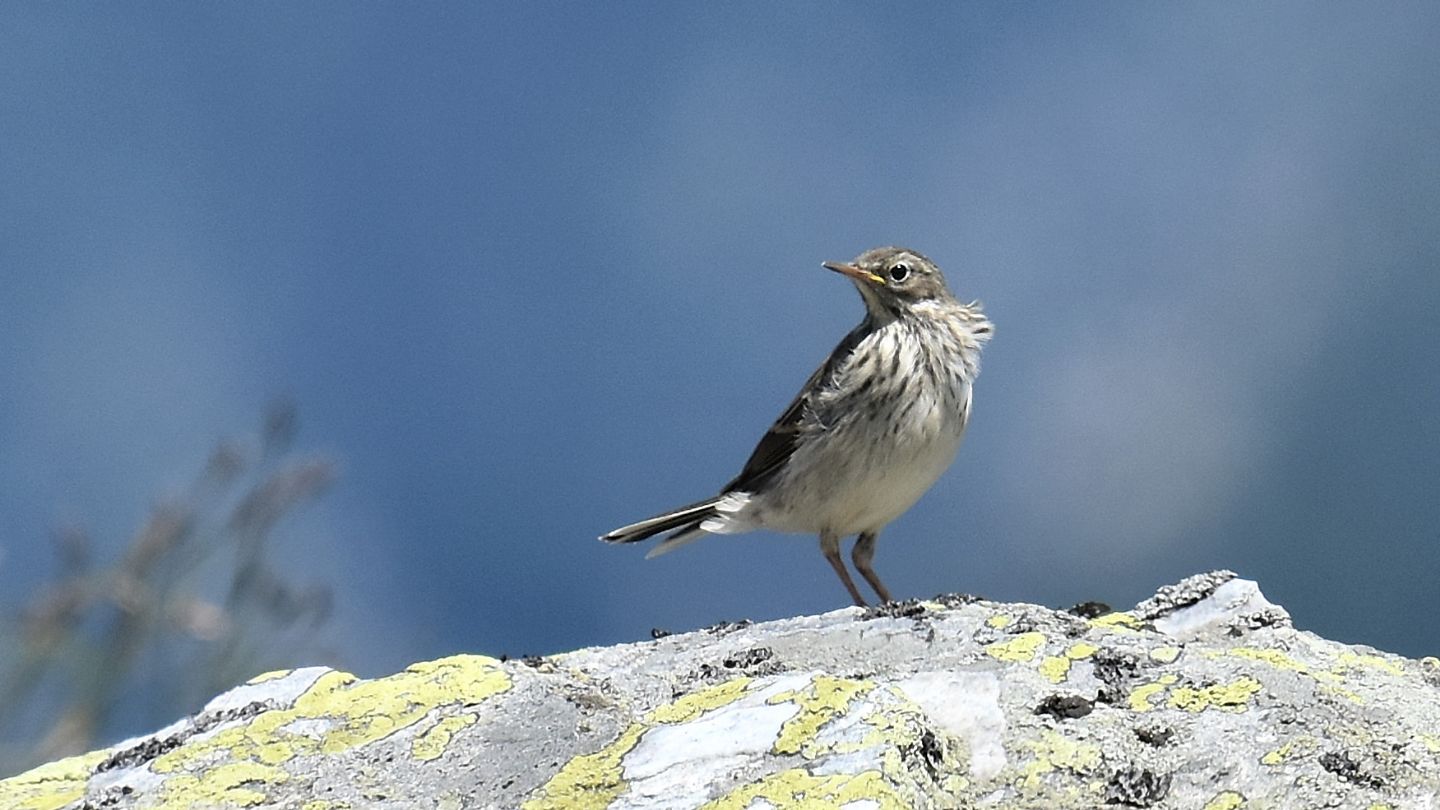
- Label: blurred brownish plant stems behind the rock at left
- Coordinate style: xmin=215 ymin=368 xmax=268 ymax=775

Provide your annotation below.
xmin=0 ymin=404 xmax=336 ymax=775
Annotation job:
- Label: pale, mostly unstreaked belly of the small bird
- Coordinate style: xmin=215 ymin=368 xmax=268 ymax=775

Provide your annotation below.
xmin=763 ymin=392 xmax=965 ymax=535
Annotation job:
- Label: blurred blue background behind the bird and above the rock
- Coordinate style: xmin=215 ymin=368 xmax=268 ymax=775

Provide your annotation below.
xmin=0 ymin=3 xmax=1440 ymax=773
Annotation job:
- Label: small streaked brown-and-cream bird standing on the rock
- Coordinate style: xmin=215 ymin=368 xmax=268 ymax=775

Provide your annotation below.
xmin=600 ymin=246 xmax=994 ymax=607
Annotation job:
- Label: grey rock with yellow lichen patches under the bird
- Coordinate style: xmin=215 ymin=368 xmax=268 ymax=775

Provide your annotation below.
xmin=0 ymin=571 xmax=1440 ymax=810
